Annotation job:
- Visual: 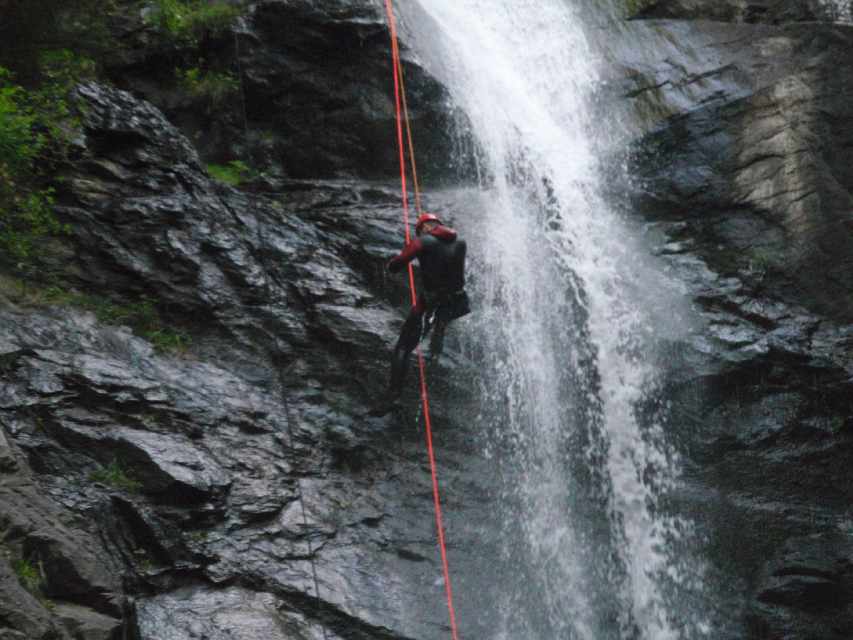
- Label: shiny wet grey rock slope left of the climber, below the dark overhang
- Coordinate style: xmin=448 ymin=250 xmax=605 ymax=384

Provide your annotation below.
xmin=0 ymin=84 xmax=484 ymax=640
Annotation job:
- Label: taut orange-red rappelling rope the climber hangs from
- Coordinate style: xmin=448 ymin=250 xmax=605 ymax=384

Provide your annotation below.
xmin=385 ymin=0 xmax=459 ymax=640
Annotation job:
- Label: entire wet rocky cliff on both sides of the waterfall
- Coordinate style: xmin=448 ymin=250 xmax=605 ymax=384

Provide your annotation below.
xmin=0 ymin=0 xmax=853 ymax=640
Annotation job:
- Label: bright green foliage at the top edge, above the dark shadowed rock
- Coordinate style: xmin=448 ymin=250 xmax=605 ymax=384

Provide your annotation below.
xmin=148 ymin=0 xmax=243 ymax=44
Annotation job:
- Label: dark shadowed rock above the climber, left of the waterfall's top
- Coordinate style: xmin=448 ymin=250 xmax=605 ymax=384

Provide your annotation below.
xmin=107 ymin=0 xmax=454 ymax=179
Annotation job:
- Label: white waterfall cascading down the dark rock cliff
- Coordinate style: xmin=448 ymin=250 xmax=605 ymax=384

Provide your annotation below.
xmin=400 ymin=0 xmax=707 ymax=640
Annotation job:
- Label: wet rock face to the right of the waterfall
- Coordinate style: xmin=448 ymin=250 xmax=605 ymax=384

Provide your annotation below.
xmin=613 ymin=1 xmax=853 ymax=640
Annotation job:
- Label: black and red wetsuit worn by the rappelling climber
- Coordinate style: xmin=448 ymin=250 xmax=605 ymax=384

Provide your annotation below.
xmin=388 ymin=226 xmax=471 ymax=394
